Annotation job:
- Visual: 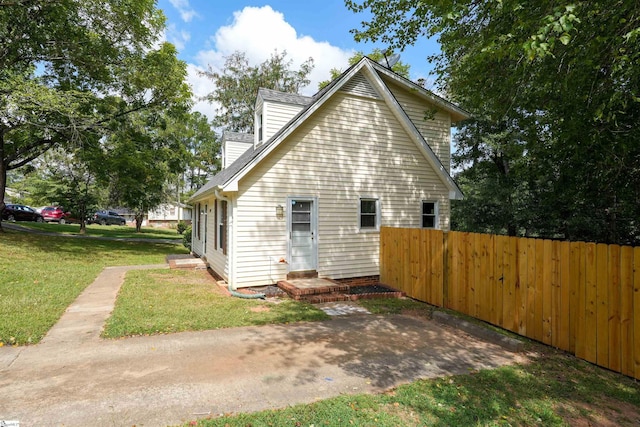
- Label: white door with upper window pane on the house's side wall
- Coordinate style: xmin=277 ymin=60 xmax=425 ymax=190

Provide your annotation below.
xmin=287 ymin=198 xmax=318 ymax=271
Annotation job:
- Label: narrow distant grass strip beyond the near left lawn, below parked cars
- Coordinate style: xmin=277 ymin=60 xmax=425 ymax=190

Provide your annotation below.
xmin=15 ymin=222 xmax=182 ymax=240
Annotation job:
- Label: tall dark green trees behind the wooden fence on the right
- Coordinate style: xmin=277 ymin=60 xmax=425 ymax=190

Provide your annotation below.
xmin=346 ymin=0 xmax=640 ymax=243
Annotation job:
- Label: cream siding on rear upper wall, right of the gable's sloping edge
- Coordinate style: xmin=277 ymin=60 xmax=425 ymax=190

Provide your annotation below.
xmin=385 ymin=80 xmax=451 ymax=172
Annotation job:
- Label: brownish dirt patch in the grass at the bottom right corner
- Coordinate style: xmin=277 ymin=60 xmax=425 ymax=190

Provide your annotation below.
xmin=557 ymin=397 xmax=640 ymax=427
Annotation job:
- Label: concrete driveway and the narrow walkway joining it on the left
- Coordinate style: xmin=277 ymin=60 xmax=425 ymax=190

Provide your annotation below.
xmin=0 ymin=266 xmax=523 ymax=427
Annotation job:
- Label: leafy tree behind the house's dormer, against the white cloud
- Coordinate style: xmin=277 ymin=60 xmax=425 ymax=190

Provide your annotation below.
xmin=203 ymin=51 xmax=313 ymax=133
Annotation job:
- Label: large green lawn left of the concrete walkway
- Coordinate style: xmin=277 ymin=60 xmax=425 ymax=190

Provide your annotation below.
xmin=0 ymin=229 xmax=188 ymax=345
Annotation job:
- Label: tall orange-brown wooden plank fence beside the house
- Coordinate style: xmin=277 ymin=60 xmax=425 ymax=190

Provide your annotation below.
xmin=380 ymin=227 xmax=640 ymax=378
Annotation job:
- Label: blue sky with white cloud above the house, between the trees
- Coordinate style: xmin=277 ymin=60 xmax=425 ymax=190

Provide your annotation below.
xmin=158 ymin=0 xmax=439 ymax=117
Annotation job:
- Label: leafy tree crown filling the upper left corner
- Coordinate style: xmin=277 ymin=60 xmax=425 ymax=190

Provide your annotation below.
xmin=0 ymin=0 xmax=190 ymax=231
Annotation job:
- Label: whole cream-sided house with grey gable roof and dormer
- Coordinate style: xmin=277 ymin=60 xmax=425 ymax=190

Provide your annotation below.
xmin=190 ymin=58 xmax=469 ymax=288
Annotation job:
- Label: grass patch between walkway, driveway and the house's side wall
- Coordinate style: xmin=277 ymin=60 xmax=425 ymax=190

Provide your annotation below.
xmin=103 ymin=270 xmax=329 ymax=338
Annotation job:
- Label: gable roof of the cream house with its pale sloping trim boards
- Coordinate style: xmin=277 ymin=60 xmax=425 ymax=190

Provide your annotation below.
xmin=189 ymin=56 xmax=471 ymax=200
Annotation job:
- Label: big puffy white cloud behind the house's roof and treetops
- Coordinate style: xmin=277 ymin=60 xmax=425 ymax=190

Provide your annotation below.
xmin=185 ymin=5 xmax=354 ymax=122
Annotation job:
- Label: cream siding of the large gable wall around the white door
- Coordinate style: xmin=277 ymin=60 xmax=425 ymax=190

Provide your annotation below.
xmin=234 ymin=92 xmax=449 ymax=287
